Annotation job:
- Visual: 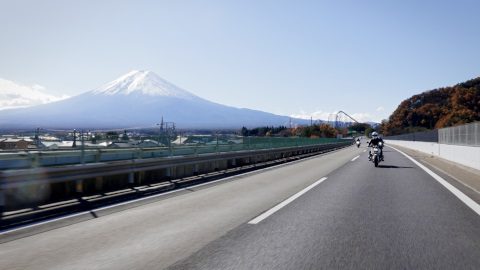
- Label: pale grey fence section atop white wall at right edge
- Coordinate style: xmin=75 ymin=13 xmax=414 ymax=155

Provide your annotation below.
xmin=438 ymin=122 xmax=480 ymax=146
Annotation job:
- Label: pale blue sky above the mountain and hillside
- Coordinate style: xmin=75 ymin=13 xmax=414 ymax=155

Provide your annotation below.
xmin=0 ymin=0 xmax=480 ymax=121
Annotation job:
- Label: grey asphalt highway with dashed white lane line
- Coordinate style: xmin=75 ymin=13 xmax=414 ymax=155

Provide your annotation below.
xmin=0 ymin=144 xmax=480 ymax=269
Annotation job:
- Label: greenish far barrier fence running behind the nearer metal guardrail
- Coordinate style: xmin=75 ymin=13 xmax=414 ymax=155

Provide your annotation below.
xmin=0 ymin=137 xmax=342 ymax=170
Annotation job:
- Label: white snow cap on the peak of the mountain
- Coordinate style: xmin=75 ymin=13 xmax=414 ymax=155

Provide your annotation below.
xmin=93 ymin=70 xmax=198 ymax=99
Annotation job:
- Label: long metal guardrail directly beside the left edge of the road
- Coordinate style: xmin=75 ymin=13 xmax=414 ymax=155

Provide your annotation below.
xmin=0 ymin=140 xmax=353 ymax=231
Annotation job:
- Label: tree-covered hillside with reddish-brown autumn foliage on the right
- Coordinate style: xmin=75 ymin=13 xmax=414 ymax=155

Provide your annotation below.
xmin=381 ymin=77 xmax=480 ymax=136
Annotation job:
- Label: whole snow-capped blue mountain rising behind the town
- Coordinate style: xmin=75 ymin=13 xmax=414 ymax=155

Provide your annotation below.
xmin=0 ymin=71 xmax=306 ymax=129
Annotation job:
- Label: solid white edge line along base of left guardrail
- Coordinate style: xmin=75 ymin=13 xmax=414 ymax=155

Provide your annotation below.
xmin=0 ymin=149 xmax=344 ymax=235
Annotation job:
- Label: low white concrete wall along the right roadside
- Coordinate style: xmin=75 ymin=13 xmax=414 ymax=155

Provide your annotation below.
xmin=386 ymin=140 xmax=480 ymax=170
